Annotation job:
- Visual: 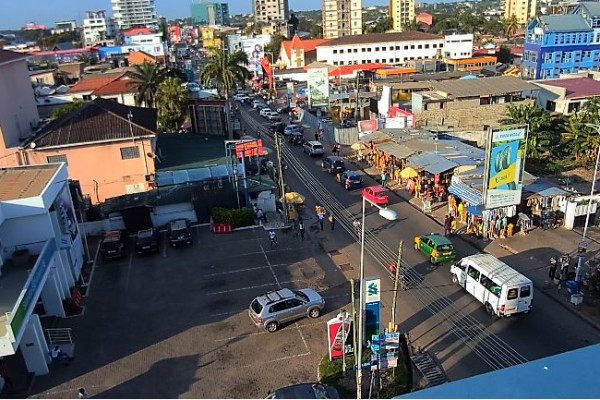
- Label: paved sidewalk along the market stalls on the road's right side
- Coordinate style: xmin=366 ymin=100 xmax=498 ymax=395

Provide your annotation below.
xmin=346 ymin=158 xmax=600 ymax=329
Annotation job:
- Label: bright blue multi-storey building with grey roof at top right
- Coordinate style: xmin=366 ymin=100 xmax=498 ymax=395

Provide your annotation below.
xmin=522 ymin=2 xmax=600 ymax=79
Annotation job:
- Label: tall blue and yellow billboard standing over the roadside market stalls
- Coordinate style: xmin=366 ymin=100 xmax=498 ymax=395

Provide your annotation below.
xmin=483 ymin=125 xmax=527 ymax=209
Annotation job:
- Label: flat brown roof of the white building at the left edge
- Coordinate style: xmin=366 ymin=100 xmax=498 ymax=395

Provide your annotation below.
xmin=0 ymin=164 xmax=60 ymax=201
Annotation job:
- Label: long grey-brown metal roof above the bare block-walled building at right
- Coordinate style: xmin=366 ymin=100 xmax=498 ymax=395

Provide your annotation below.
xmin=433 ymin=76 xmax=539 ymax=98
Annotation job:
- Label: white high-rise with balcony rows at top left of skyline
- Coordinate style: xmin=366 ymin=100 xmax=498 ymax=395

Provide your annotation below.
xmin=111 ymin=0 xmax=158 ymax=30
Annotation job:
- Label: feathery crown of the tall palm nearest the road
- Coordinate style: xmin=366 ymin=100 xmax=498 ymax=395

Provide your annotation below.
xmin=200 ymin=49 xmax=250 ymax=97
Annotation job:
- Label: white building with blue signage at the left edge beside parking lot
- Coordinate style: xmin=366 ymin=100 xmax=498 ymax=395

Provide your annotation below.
xmin=0 ymin=163 xmax=83 ymax=375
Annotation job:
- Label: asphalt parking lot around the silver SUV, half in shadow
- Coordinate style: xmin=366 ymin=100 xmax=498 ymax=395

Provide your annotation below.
xmin=32 ymin=226 xmax=350 ymax=398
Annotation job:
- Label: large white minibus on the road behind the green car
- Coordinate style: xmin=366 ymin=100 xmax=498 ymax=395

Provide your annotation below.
xmin=450 ymin=254 xmax=533 ymax=317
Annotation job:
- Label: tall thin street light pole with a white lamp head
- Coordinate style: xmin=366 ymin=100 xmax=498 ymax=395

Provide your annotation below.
xmin=356 ymin=196 xmax=398 ymax=399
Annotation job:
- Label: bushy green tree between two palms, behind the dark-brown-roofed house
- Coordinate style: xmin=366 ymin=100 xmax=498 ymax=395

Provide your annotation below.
xmin=156 ymin=77 xmax=188 ymax=131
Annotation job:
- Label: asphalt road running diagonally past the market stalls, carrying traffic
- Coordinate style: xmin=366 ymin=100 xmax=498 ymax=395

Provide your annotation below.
xmin=242 ymin=102 xmax=600 ymax=380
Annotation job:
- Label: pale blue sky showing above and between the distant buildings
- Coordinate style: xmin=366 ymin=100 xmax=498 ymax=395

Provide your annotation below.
xmin=0 ymin=0 xmax=388 ymax=30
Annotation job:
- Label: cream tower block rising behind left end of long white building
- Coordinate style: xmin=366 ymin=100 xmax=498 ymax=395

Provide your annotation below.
xmin=322 ymin=0 xmax=362 ymax=39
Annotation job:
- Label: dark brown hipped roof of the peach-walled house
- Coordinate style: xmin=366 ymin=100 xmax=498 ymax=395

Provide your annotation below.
xmin=24 ymin=97 xmax=157 ymax=149
